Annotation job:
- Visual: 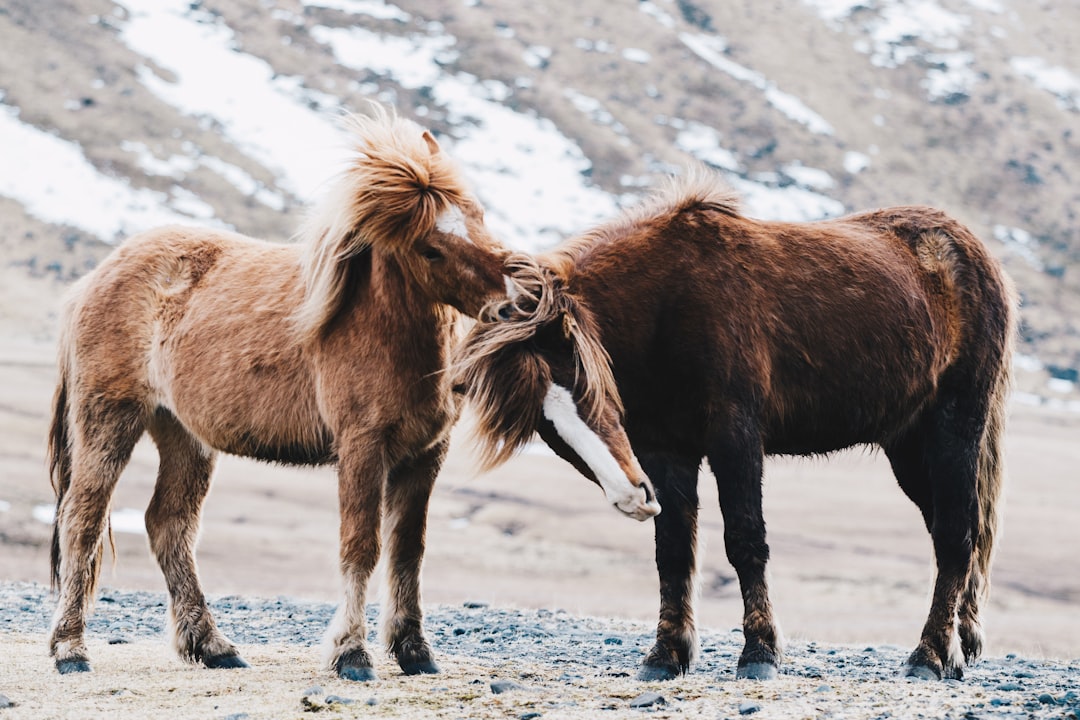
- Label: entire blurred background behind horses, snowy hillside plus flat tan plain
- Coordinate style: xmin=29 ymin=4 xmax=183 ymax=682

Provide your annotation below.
xmin=0 ymin=0 xmax=1080 ymax=657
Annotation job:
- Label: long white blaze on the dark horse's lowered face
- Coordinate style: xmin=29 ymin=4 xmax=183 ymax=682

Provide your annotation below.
xmin=543 ymin=383 xmax=645 ymax=514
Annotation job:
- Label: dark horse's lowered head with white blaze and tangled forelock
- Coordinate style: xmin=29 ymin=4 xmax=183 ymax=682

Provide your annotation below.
xmin=455 ymin=255 xmax=660 ymax=520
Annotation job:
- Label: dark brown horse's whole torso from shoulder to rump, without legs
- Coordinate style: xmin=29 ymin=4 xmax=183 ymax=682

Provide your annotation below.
xmin=573 ymin=202 xmax=1010 ymax=454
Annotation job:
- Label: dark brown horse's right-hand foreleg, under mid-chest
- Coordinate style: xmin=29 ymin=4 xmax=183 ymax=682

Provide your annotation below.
xmin=708 ymin=427 xmax=782 ymax=680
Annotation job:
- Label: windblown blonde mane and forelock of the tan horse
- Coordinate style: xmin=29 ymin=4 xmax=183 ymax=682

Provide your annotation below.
xmin=294 ymin=104 xmax=469 ymax=340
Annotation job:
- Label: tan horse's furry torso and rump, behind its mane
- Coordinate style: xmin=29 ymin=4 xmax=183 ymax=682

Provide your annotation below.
xmin=60 ymin=227 xmax=330 ymax=462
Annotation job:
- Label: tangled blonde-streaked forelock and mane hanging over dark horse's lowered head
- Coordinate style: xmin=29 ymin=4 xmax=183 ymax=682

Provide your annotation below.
xmin=451 ymin=254 xmax=622 ymax=468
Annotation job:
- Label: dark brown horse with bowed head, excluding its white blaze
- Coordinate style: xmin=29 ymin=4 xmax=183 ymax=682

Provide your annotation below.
xmin=458 ymin=172 xmax=1014 ymax=679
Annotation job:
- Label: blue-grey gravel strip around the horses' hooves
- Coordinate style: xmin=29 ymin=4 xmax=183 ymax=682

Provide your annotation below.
xmin=0 ymin=583 xmax=1080 ymax=720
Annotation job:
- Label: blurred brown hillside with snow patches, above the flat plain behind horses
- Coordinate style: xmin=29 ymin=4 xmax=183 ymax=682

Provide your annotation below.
xmin=0 ymin=0 xmax=1080 ymax=408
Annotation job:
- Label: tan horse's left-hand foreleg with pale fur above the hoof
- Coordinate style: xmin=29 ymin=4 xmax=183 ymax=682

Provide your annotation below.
xmin=326 ymin=439 xmax=389 ymax=681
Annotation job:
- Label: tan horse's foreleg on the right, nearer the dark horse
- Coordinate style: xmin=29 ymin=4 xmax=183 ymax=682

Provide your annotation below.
xmin=382 ymin=441 xmax=447 ymax=675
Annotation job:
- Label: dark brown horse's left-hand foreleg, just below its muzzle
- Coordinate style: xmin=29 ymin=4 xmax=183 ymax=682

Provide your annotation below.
xmin=637 ymin=454 xmax=698 ymax=680
